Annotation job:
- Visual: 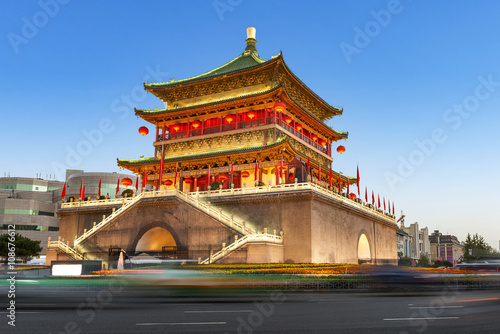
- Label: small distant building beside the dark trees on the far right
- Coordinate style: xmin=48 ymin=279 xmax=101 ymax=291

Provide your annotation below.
xmin=429 ymin=230 xmax=464 ymax=264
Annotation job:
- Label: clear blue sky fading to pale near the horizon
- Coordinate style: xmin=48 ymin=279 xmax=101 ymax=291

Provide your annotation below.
xmin=0 ymin=0 xmax=500 ymax=248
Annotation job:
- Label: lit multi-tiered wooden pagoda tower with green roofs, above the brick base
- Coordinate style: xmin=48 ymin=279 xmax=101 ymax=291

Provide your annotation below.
xmin=118 ymin=28 xmax=356 ymax=191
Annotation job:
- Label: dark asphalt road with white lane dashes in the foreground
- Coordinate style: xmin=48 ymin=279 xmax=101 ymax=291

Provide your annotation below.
xmin=0 ymin=288 xmax=500 ymax=334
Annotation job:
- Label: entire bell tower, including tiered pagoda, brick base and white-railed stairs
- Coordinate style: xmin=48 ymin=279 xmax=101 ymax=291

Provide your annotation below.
xmin=47 ymin=28 xmax=397 ymax=267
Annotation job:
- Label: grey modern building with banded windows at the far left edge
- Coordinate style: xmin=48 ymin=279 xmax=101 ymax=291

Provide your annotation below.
xmin=0 ymin=177 xmax=64 ymax=254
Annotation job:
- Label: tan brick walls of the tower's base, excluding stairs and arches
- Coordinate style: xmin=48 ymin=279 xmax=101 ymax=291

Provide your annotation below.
xmin=55 ymin=190 xmax=397 ymax=264
